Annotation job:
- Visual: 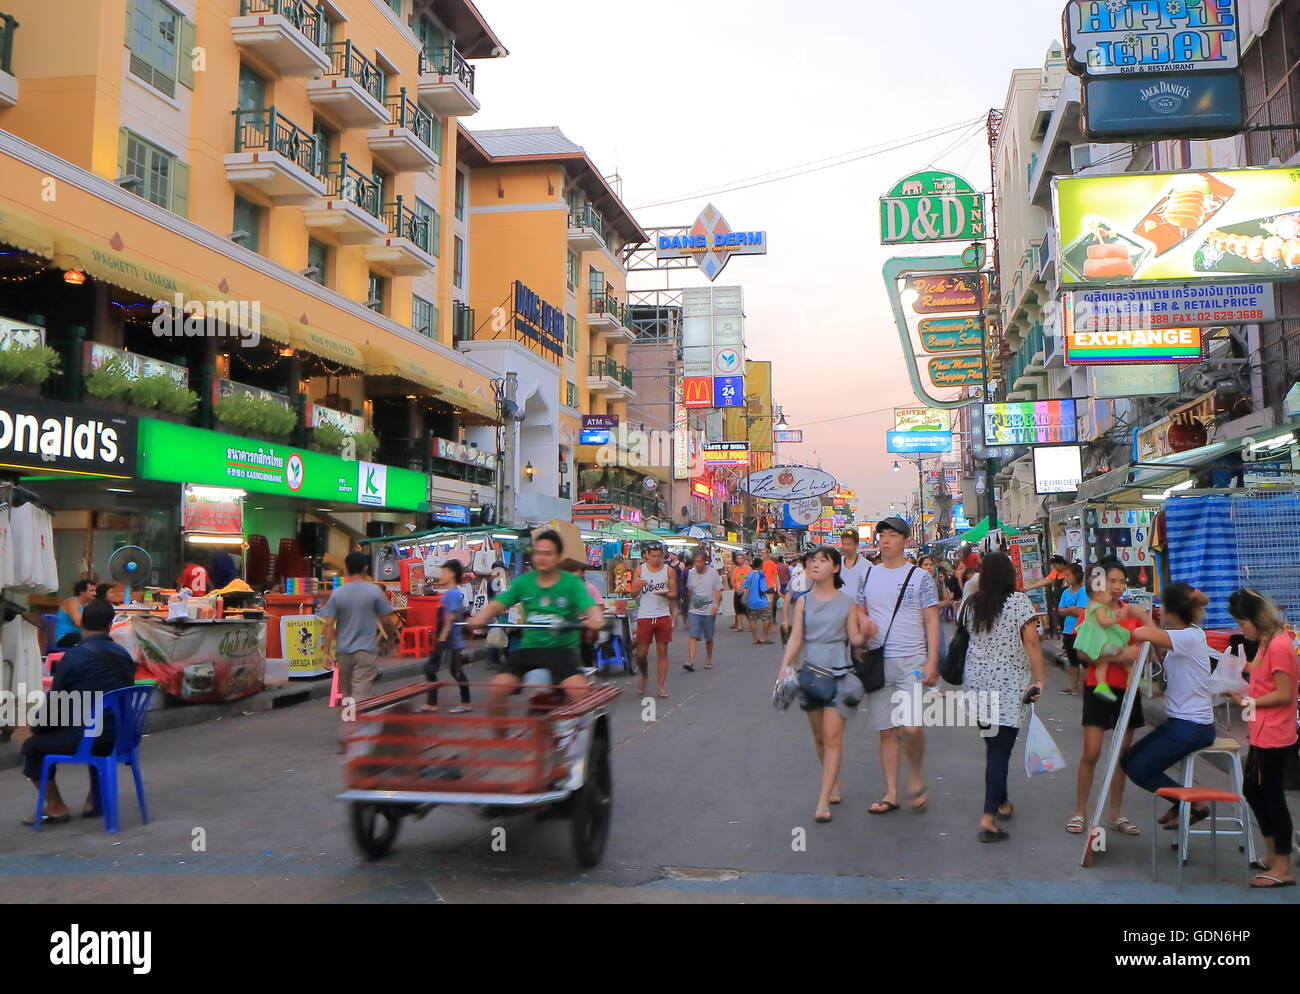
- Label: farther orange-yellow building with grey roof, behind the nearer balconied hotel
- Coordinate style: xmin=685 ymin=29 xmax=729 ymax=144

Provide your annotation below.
xmin=454 ymin=126 xmax=646 ymax=520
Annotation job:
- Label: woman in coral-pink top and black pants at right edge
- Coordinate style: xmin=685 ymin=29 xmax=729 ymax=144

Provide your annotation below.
xmin=1227 ymin=590 xmax=1297 ymax=890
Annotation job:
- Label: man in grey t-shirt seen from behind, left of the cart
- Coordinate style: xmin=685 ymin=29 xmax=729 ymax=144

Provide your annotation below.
xmin=320 ymin=552 xmax=398 ymax=743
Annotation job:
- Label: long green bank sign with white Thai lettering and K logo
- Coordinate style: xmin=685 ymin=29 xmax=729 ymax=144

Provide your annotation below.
xmin=138 ymin=418 xmax=429 ymax=511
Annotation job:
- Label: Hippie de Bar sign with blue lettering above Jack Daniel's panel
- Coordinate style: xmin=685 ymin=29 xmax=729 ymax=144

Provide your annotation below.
xmin=1065 ymin=0 xmax=1240 ymax=77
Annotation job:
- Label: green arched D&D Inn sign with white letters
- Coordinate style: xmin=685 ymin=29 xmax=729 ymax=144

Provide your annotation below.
xmin=880 ymin=170 xmax=984 ymax=246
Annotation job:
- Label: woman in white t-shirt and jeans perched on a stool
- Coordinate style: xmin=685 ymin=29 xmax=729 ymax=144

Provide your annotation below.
xmin=1119 ymin=583 xmax=1214 ymax=829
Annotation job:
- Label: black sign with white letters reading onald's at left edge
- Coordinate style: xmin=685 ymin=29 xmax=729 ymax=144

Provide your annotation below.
xmin=0 ymin=392 xmax=137 ymax=479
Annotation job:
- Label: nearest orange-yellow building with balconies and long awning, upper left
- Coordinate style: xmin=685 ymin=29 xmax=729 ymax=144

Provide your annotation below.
xmin=0 ymin=0 xmax=517 ymax=582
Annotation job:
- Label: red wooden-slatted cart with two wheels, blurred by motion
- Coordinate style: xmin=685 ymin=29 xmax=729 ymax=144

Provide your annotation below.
xmin=339 ymin=625 xmax=621 ymax=868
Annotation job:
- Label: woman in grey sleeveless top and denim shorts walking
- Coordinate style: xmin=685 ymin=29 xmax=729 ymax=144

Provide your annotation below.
xmin=777 ymin=546 xmax=875 ymax=824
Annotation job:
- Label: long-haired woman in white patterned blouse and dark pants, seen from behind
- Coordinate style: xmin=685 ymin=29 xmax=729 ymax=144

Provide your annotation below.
xmin=962 ymin=552 xmax=1043 ymax=842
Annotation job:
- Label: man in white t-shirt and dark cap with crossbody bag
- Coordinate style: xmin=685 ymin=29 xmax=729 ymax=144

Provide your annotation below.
xmin=857 ymin=517 xmax=939 ymax=815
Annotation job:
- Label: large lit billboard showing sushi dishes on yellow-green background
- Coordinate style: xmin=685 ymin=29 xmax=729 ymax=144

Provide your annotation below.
xmin=1052 ymin=169 xmax=1300 ymax=283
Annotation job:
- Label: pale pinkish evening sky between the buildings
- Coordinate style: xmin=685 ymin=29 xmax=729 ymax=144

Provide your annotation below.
xmin=464 ymin=0 xmax=1062 ymax=517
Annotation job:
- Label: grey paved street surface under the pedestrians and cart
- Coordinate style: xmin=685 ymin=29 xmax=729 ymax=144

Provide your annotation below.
xmin=0 ymin=630 xmax=1296 ymax=903
